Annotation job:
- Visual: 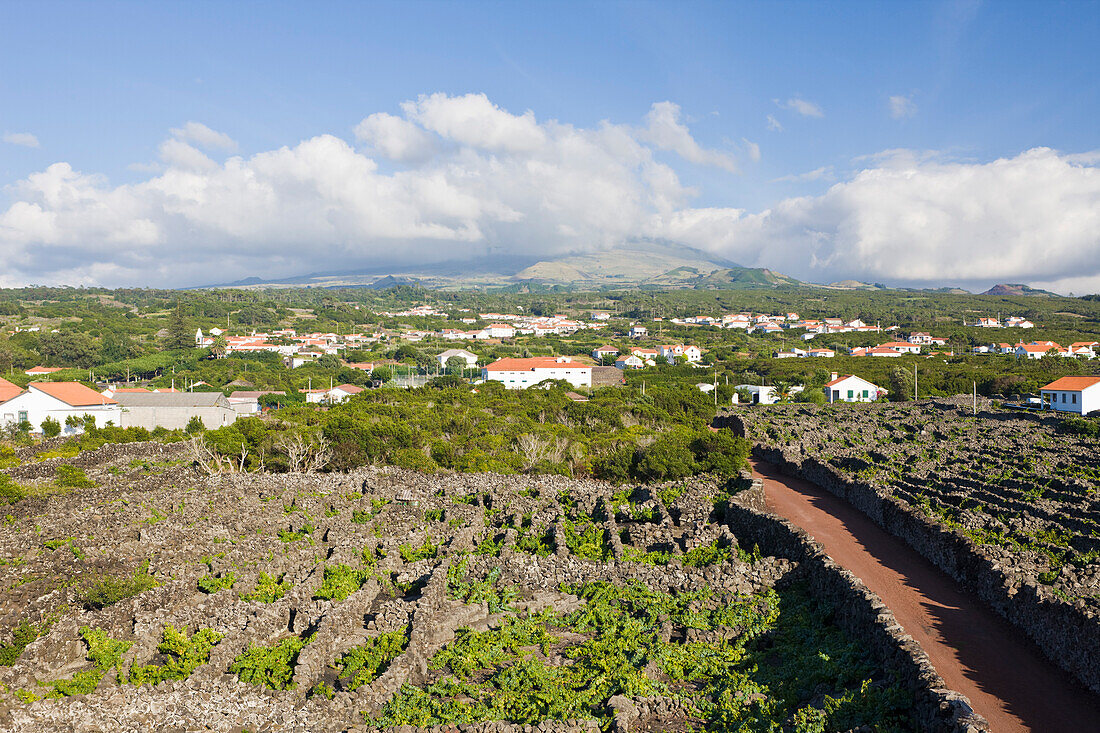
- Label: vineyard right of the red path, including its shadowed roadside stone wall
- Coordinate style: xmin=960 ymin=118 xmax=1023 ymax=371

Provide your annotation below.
xmin=718 ymin=401 xmax=1100 ymax=692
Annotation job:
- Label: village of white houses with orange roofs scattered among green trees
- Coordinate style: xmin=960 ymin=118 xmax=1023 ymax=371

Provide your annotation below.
xmin=0 ymin=297 xmax=1100 ymax=435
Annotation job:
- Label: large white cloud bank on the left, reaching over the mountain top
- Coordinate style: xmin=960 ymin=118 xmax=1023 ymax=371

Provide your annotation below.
xmin=0 ymin=95 xmax=705 ymax=285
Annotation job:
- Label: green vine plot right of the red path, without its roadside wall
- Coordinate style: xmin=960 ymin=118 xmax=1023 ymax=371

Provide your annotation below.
xmin=740 ymin=400 xmax=1100 ymax=614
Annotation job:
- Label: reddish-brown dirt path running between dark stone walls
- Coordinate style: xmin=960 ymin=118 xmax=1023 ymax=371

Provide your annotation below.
xmin=754 ymin=461 xmax=1100 ymax=733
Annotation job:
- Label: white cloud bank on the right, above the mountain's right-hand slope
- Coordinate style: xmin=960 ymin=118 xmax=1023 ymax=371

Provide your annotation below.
xmin=658 ymin=147 xmax=1100 ymax=289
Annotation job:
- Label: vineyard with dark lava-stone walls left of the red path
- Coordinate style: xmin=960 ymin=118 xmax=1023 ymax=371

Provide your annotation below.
xmin=0 ymin=435 xmax=986 ymax=732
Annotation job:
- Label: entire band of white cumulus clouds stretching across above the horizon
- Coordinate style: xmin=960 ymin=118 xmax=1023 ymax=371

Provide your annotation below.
xmin=0 ymin=95 xmax=1100 ymax=292
